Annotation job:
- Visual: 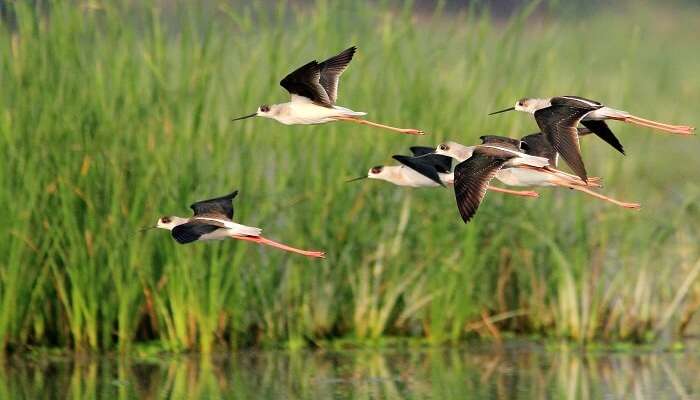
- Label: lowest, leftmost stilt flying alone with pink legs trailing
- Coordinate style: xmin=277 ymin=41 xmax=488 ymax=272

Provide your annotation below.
xmin=154 ymin=190 xmax=325 ymax=258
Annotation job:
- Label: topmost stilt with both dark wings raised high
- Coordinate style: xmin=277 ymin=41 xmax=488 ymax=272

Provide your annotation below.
xmin=234 ymin=46 xmax=423 ymax=135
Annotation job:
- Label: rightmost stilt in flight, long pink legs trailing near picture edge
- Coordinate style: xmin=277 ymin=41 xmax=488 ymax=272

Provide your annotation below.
xmin=489 ymin=96 xmax=695 ymax=181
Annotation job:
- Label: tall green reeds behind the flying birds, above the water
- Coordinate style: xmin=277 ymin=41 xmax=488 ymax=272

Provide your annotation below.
xmin=0 ymin=0 xmax=700 ymax=353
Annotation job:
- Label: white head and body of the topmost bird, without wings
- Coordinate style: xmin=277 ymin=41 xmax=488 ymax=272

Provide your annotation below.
xmin=257 ymin=95 xmax=367 ymax=125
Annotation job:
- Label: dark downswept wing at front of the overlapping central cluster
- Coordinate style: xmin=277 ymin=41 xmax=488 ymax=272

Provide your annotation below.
xmin=454 ymin=149 xmax=515 ymax=223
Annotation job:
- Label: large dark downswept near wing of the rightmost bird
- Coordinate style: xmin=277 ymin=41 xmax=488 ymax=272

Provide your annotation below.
xmin=535 ymin=104 xmax=600 ymax=182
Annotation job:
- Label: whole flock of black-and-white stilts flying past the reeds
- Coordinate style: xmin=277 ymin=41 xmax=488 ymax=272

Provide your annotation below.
xmin=154 ymin=46 xmax=695 ymax=258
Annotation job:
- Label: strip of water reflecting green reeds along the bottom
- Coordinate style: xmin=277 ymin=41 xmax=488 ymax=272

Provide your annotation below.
xmin=0 ymin=344 xmax=700 ymax=400
